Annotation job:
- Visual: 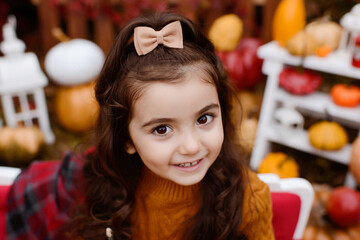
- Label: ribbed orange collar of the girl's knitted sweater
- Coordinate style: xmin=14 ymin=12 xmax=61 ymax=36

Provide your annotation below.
xmin=138 ymin=166 xmax=201 ymax=203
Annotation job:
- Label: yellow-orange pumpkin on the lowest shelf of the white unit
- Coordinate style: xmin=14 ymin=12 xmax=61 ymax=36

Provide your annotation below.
xmin=308 ymin=120 xmax=348 ymax=151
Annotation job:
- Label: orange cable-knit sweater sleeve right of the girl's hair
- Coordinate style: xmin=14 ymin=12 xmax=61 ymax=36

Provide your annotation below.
xmin=240 ymin=172 xmax=275 ymax=240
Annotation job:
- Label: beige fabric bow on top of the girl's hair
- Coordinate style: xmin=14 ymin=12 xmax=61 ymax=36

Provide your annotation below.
xmin=134 ymin=21 xmax=183 ymax=56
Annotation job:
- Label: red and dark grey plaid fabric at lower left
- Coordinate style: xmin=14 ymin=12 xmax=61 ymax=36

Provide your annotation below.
xmin=6 ymin=152 xmax=84 ymax=240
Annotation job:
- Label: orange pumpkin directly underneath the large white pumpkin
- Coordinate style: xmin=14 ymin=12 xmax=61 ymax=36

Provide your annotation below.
xmin=55 ymin=82 xmax=99 ymax=133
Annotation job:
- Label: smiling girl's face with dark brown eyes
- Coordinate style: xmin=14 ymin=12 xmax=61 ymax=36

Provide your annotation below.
xmin=127 ymin=73 xmax=224 ymax=185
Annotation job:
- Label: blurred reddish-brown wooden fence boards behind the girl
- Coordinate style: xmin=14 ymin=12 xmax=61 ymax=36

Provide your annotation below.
xmin=36 ymin=0 xmax=281 ymax=54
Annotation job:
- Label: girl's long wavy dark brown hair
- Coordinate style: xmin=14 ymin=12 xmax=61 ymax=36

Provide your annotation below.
xmin=71 ymin=13 xmax=247 ymax=240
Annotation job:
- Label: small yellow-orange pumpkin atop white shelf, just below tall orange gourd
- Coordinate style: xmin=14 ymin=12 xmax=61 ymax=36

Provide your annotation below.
xmin=285 ymin=31 xmax=316 ymax=56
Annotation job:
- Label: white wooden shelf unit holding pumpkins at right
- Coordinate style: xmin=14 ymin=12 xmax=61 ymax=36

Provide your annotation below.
xmin=250 ymin=42 xmax=360 ymax=187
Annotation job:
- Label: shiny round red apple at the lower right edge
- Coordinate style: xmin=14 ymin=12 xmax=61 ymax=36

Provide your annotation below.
xmin=326 ymin=186 xmax=360 ymax=227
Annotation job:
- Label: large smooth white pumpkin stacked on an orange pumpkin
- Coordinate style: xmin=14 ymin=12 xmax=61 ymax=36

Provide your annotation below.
xmin=45 ymin=39 xmax=105 ymax=86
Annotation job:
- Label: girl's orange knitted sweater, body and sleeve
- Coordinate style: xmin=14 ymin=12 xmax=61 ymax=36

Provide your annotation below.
xmin=131 ymin=170 xmax=274 ymax=240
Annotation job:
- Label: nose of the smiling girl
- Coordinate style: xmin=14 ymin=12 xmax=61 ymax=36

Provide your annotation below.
xmin=179 ymin=131 xmax=201 ymax=155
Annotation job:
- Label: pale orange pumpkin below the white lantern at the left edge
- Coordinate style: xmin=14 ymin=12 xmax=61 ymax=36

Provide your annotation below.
xmin=0 ymin=126 xmax=44 ymax=166
